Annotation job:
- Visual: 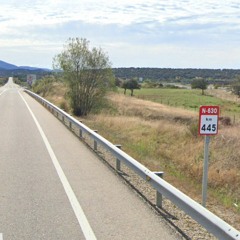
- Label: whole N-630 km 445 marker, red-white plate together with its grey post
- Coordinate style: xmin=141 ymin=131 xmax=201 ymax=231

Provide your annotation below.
xmin=198 ymin=106 xmax=220 ymax=207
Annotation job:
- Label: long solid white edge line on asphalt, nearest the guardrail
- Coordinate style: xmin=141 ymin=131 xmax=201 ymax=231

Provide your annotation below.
xmin=18 ymin=91 xmax=97 ymax=240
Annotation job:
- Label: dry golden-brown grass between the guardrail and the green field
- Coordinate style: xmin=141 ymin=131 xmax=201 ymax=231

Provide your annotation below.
xmin=86 ymin=94 xmax=240 ymax=206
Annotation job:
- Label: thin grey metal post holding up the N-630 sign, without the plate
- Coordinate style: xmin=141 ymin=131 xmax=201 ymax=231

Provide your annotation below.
xmin=202 ymin=136 xmax=210 ymax=207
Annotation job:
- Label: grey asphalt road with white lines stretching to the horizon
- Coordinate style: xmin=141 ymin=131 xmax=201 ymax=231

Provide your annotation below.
xmin=0 ymin=79 xmax=180 ymax=240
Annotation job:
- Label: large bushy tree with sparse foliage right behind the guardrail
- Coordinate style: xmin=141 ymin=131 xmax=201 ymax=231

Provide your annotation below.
xmin=53 ymin=38 xmax=114 ymax=116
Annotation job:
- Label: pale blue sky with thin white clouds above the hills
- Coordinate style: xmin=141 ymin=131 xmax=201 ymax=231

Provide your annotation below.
xmin=0 ymin=0 xmax=240 ymax=69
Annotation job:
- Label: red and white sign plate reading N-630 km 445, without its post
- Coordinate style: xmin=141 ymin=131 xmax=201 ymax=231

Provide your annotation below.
xmin=198 ymin=106 xmax=220 ymax=135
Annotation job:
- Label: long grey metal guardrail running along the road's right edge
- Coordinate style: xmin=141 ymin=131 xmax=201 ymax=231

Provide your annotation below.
xmin=24 ymin=89 xmax=240 ymax=240
